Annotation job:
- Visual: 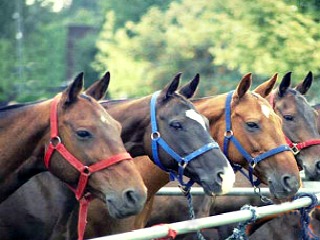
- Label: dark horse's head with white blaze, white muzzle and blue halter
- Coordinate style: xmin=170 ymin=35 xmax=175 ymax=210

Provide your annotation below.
xmin=145 ymin=73 xmax=234 ymax=195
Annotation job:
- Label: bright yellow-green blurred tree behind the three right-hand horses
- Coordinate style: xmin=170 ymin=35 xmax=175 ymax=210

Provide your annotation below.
xmin=94 ymin=0 xmax=320 ymax=100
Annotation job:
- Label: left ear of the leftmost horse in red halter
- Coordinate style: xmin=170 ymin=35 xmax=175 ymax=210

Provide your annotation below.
xmin=61 ymin=72 xmax=83 ymax=105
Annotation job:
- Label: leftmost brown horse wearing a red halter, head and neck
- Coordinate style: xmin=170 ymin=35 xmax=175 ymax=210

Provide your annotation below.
xmin=0 ymin=73 xmax=147 ymax=239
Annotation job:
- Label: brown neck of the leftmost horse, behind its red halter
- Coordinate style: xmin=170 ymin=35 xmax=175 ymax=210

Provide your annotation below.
xmin=0 ymin=101 xmax=50 ymax=185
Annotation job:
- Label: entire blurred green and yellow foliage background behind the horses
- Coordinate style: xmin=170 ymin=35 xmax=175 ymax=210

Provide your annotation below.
xmin=0 ymin=0 xmax=320 ymax=102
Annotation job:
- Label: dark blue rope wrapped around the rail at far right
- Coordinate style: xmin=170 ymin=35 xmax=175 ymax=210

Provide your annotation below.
xmin=294 ymin=193 xmax=320 ymax=240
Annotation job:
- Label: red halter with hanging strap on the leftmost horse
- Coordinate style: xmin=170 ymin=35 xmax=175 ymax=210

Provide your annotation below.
xmin=44 ymin=95 xmax=132 ymax=239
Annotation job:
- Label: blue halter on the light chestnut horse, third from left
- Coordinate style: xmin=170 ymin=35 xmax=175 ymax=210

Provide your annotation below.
xmin=223 ymin=91 xmax=291 ymax=186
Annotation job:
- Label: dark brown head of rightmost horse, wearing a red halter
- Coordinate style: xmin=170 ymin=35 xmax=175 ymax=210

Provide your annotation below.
xmin=270 ymin=72 xmax=320 ymax=181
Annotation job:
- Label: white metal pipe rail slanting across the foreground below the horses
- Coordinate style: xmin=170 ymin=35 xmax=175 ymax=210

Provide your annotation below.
xmin=89 ymin=193 xmax=320 ymax=240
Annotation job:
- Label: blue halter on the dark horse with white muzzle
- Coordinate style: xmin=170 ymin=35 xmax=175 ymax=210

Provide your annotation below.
xmin=150 ymin=91 xmax=219 ymax=189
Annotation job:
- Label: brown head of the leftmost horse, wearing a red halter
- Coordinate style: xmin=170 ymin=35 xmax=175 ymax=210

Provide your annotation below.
xmin=47 ymin=73 xmax=146 ymax=218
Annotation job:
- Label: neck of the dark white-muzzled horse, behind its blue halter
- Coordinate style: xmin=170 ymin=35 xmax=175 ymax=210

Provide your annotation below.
xmin=101 ymin=97 xmax=150 ymax=157
